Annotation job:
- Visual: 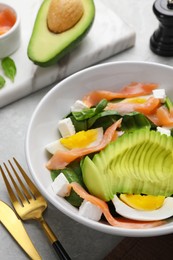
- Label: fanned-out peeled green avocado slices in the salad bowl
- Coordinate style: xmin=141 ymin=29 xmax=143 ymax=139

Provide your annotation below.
xmin=82 ymin=129 xmax=173 ymax=201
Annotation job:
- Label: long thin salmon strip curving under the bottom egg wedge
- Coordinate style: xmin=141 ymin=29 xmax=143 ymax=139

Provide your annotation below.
xmin=69 ymin=182 xmax=165 ymax=229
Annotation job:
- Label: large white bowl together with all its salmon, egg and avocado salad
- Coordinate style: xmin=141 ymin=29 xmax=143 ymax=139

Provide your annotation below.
xmin=26 ymin=62 xmax=173 ymax=236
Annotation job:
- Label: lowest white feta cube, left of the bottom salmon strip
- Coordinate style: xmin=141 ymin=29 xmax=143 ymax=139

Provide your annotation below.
xmin=79 ymin=200 xmax=102 ymax=221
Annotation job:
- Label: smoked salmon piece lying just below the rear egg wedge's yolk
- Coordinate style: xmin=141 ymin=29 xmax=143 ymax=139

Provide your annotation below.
xmin=106 ymin=97 xmax=161 ymax=115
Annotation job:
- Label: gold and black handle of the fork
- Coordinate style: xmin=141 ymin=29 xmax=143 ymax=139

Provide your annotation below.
xmin=39 ymin=217 xmax=71 ymax=260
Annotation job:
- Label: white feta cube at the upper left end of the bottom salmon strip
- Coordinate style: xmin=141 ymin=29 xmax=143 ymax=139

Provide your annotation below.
xmin=51 ymin=172 xmax=70 ymax=197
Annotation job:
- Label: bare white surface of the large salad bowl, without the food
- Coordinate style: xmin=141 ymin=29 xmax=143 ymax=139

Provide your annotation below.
xmin=26 ymin=62 xmax=173 ymax=237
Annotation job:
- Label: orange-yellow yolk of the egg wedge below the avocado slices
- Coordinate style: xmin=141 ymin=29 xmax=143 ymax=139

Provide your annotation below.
xmin=120 ymin=194 xmax=165 ymax=210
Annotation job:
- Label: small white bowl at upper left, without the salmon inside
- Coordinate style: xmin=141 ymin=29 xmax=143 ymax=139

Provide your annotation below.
xmin=0 ymin=3 xmax=20 ymax=59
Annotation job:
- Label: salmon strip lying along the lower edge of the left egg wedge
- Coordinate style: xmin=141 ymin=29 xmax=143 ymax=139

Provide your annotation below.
xmin=46 ymin=119 xmax=122 ymax=170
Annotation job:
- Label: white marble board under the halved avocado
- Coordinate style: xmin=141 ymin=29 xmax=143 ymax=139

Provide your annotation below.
xmin=0 ymin=0 xmax=135 ymax=107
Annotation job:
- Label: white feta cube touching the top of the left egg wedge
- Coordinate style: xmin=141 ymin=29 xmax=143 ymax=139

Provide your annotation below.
xmin=58 ymin=117 xmax=76 ymax=137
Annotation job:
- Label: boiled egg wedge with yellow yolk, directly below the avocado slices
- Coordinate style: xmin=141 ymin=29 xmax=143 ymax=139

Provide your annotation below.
xmin=112 ymin=194 xmax=173 ymax=221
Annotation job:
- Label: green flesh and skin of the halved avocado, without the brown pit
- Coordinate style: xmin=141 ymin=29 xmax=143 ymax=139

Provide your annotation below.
xmin=27 ymin=0 xmax=95 ymax=67
